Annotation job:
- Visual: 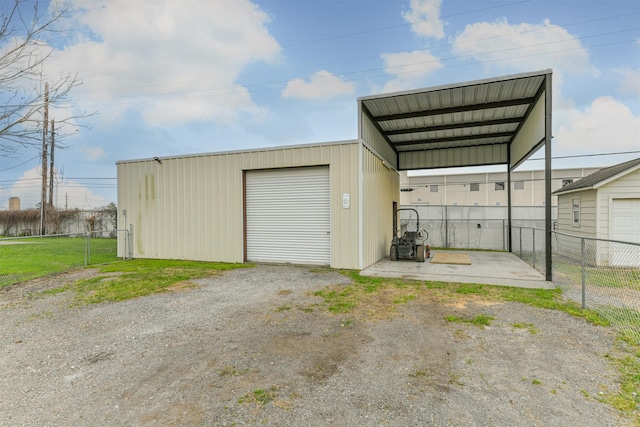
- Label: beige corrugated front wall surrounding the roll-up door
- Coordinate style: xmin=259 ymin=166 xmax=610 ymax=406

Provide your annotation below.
xmin=118 ymin=141 xmax=361 ymax=268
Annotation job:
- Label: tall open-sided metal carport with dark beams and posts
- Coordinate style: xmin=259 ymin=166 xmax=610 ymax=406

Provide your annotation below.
xmin=358 ymin=70 xmax=552 ymax=281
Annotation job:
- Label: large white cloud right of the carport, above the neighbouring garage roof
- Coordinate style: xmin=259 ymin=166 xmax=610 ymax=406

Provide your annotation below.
xmin=553 ymin=96 xmax=640 ymax=156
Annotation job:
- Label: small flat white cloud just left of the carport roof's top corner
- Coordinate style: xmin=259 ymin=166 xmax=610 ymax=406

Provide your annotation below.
xmin=282 ymin=70 xmax=355 ymax=99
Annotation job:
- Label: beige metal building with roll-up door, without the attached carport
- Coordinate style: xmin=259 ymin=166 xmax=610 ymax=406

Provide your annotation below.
xmin=118 ymin=140 xmax=400 ymax=268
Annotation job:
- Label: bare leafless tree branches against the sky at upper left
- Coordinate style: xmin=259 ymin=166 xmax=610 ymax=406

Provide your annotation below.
xmin=0 ymin=0 xmax=88 ymax=154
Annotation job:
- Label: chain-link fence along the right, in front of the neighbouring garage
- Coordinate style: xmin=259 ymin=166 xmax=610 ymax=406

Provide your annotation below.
xmin=512 ymin=227 xmax=640 ymax=344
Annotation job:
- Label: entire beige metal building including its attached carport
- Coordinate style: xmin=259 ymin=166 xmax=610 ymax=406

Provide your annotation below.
xmin=117 ymin=70 xmax=551 ymax=275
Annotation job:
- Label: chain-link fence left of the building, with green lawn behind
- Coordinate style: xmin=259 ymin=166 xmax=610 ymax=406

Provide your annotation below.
xmin=0 ymin=230 xmax=130 ymax=288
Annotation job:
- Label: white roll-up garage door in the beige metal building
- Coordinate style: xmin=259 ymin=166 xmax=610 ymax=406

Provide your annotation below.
xmin=245 ymin=166 xmax=331 ymax=265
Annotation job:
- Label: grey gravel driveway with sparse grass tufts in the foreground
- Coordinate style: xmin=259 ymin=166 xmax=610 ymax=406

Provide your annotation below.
xmin=0 ymin=265 xmax=629 ymax=426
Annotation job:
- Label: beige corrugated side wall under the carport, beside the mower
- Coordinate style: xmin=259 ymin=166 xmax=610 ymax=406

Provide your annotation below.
xmin=362 ymin=146 xmax=400 ymax=268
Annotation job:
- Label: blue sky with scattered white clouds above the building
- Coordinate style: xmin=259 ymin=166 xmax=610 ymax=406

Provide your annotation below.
xmin=0 ymin=0 xmax=640 ymax=209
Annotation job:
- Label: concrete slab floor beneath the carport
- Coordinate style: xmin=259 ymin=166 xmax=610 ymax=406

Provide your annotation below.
xmin=360 ymin=250 xmax=555 ymax=289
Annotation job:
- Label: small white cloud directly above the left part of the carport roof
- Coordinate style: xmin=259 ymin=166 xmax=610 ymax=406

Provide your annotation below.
xmin=381 ymin=50 xmax=444 ymax=92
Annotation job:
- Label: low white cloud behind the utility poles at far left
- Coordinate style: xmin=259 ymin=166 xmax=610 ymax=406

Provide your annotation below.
xmin=8 ymin=168 xmax=108 ymax=209
